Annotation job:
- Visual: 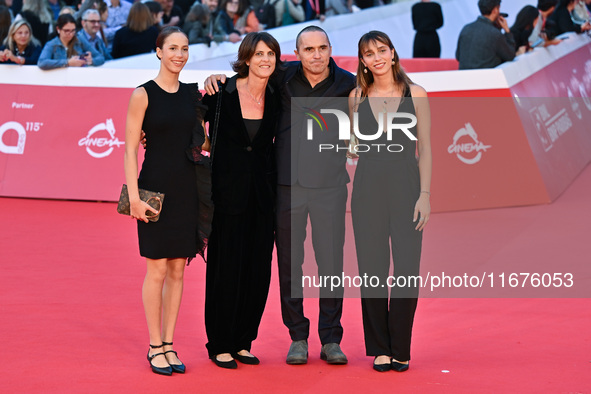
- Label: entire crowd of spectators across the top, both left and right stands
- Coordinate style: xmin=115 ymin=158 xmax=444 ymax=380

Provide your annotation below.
xmin=0 ymin=0 xmax=591 ymax=69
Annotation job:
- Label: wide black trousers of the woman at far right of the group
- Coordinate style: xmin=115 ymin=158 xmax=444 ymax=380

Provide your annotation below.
xmin=351 ymin=157 xmax=422 ymax=361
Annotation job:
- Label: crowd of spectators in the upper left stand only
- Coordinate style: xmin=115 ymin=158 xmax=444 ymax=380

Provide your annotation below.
xmin=0 ymin=0 xmax=397 ymax=69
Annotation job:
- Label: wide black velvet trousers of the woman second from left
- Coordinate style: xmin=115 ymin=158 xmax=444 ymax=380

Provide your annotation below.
xmin=205 ymin=196 xmax=274 ymax=357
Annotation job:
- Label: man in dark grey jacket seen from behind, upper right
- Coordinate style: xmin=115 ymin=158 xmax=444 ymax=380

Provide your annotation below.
xmin=456 ymin=0 xmax=515 ymax=70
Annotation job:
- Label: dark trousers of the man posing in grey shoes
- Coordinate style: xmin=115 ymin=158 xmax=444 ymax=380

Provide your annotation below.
xmin=276 ymin=184 xmax=347 ymax=345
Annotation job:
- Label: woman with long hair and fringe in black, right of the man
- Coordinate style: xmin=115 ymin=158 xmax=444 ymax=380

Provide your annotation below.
xmin=350 ymin=31 xmax=432 ymax=372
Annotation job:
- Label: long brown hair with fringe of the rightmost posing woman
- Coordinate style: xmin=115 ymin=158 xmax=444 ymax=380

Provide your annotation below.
xmin=357 ymin=30 xmax=413 ymax=97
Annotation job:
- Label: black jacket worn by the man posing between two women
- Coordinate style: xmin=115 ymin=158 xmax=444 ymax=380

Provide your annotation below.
xmin=275 ymin=58 xmax=355 ymax=188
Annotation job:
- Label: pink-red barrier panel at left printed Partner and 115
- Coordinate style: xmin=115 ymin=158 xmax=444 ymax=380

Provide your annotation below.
xmin=0 ymin=85 xmax=133 ymax=201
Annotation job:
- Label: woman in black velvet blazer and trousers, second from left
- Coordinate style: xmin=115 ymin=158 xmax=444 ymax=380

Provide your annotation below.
xmin=203 ymin=33 xmax=281 ymax=369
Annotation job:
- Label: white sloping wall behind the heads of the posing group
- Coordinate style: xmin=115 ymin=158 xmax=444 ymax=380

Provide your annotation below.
xmin=103 ymin=0 xmax=536 ymax=70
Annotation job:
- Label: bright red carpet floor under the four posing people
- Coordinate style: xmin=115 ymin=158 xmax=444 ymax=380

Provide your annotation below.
xmin=0 ymin=167 xmax=591 ymax=393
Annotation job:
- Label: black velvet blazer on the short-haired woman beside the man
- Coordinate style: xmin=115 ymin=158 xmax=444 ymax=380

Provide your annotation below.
xmin=203 ymin=76 xmax=279 ymax=214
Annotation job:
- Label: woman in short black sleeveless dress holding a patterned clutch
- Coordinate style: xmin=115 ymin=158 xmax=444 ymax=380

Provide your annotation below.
xmin=125 ymin=27 xmax=205 ymax=375
